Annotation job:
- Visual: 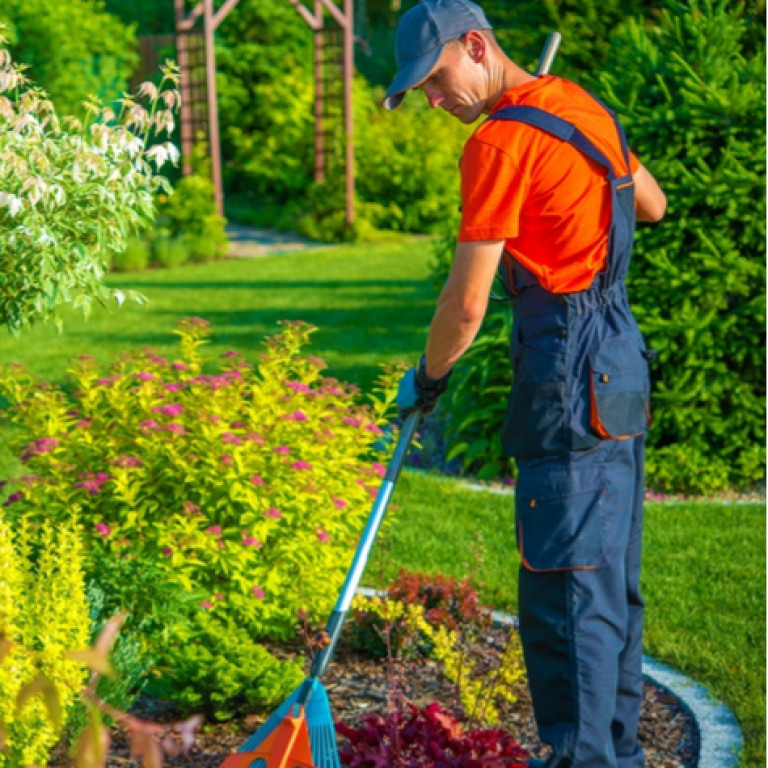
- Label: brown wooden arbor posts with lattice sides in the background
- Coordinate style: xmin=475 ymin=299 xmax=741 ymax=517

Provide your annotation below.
xmin=174 ymin=0 xmax=355 ymax=226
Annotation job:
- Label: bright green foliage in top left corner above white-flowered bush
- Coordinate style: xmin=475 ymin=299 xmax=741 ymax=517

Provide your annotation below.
xmin=0 ymin=0 xmax=139 ymax=117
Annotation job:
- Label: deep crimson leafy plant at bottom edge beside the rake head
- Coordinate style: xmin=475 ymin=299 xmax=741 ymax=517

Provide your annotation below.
xmin=336 ymin=704 xmax=530 ymax=768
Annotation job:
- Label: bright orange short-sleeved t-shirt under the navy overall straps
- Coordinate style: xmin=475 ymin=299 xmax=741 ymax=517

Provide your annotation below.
xmin=458 ymin=75 xmax=640 ymax=293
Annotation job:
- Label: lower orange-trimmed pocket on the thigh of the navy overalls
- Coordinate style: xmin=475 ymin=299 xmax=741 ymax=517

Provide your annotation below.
xmin=515 ymin=480 xmax=606 ymax=571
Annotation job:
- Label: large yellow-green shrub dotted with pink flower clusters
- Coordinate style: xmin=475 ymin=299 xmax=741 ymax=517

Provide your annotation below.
xmin=0 ymin=318 xmax=402 ymax=638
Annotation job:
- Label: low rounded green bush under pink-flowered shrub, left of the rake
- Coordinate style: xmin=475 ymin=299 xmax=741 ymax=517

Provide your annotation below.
xmin=148 ymin=613 xmax=304 ymax=720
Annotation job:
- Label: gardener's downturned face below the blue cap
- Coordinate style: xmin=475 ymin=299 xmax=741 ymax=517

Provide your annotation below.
xmin=416 ymin=44 xmax=486 ymax=124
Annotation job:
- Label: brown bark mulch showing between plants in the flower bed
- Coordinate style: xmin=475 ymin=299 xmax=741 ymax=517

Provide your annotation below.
xmin=93 ymin=630 xmax=699 ymax=768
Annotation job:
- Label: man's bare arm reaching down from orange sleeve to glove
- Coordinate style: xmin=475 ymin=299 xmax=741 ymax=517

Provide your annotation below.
xmin=426 ymin=240 xmax=504 ymax=379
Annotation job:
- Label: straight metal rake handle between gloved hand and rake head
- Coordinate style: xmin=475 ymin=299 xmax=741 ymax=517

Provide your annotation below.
xmin=299 ymin=411 xmax=421 ymax=688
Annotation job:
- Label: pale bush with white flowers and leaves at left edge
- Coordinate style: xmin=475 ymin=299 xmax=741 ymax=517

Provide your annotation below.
xmin=0 ymin=28 xmax=179 ymax=332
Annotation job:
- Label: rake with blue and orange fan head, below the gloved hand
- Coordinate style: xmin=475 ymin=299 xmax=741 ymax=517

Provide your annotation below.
xmin=220 ymin=412 xmax=419 ymax=768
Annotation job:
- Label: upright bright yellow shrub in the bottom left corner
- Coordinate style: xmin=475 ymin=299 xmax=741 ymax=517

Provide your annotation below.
xmin=0 ymin=518 xmax=89 ymax=768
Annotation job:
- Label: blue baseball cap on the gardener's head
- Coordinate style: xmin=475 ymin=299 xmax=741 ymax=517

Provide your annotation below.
xmin=382 ymin=0 xmax=491 ymax=109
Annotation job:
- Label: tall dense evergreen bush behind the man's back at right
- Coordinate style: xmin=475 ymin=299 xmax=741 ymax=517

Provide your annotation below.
xmin=599 ymin=0 xmax=766 ymax=487
